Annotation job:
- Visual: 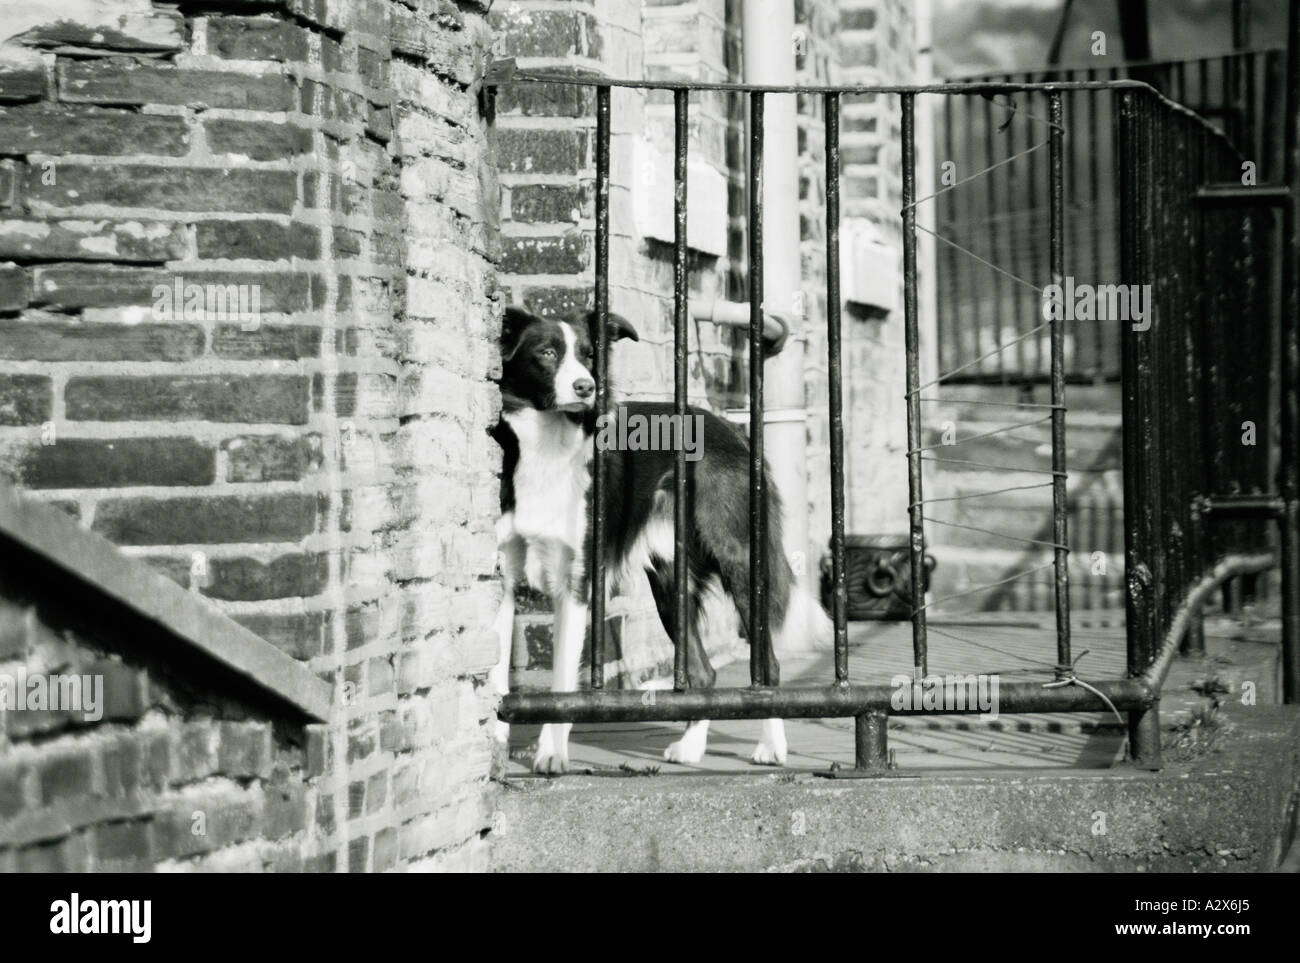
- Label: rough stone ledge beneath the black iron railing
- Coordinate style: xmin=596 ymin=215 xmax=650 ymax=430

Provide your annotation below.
xmin=491 ymin=706 xmax=1300 ymax=872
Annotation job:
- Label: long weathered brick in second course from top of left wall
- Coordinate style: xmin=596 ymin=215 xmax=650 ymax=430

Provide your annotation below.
xmin=59 ymin=57 xmax=294 ymax=110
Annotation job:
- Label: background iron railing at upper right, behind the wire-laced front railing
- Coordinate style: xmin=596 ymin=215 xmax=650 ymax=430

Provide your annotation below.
xmin=936 ymin=48 xmax=1284 ymax=385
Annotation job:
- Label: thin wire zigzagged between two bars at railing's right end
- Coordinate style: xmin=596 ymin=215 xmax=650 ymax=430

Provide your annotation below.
xmin=901 ymin=86 xmax=1076 ymax=613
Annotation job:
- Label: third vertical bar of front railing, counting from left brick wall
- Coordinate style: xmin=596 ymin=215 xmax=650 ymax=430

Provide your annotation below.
xmin=746 ymin=92 xmax=767 ymax=685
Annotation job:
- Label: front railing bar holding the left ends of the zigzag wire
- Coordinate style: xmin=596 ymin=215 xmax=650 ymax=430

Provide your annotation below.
xmin=901 ymin=94 xmax=930 ymax=676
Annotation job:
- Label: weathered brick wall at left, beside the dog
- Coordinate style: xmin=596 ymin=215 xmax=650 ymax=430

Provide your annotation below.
xmin=0 ymin=0 xmax=499 ymax=871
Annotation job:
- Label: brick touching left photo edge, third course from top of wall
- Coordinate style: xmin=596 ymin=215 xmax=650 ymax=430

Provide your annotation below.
xmin=0 ymin=104 xmax=190 ymax=155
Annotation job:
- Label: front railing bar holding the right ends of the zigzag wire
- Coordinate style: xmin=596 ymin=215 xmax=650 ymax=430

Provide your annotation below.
xmin=1048 ymin=91 xmax=1070 ymax=672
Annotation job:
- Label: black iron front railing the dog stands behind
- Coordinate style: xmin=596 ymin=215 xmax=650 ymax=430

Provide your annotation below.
xmin=495 ymin=33 xmax=1300 ymax=769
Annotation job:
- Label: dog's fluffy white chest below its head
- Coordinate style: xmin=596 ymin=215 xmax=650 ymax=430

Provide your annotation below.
xmin=504 ymin=409 xmax=592 ymax=550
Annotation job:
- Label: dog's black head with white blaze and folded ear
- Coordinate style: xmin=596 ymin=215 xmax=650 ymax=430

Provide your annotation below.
xmin=501 ymin=308 xmax=640 ymax=413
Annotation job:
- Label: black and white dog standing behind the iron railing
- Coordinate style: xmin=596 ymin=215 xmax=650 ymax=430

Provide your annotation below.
xmin=493 ymin=308 xmax=831 ymax=773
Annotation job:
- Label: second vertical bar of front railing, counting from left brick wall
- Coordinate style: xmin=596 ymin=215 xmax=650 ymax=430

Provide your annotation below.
xmin=672 ymin=90 xmax=690 ymax=691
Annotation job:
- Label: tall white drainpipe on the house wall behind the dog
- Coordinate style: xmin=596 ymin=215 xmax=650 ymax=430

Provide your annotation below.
xmin=741 ymin=0 xmax=813 ymax=582
